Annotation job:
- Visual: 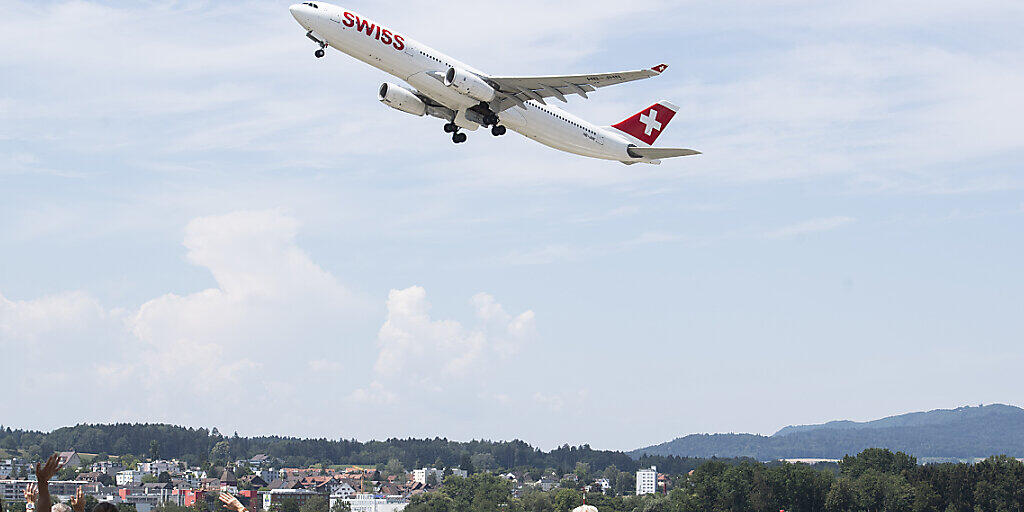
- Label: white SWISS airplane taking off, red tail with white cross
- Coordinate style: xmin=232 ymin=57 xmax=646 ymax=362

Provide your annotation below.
xmin=289 ymin=1 xmax=700 ymax=165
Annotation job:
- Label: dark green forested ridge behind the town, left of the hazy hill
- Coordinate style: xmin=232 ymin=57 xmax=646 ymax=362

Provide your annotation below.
xmin=0 ymin=424 xmax=716 ymax=473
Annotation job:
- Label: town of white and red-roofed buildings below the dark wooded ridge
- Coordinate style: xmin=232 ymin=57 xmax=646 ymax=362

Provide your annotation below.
xmin=0 ymin=452 xmax=669 ymax=512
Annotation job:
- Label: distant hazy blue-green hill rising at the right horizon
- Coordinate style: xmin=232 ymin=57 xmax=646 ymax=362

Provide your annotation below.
xmin=630 ymin=404 xmax=1024 ymax=461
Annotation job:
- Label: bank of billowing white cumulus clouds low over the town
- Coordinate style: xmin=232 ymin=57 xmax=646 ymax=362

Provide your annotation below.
xmin=0 ymin=210 xmax=535 ymax=434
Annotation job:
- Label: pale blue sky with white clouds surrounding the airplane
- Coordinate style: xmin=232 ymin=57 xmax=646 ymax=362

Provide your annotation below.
xmin=0 ymin=0 xmax=1024 ymax=449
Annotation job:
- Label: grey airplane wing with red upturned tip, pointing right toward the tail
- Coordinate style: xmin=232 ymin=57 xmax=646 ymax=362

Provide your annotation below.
xmin=487 ymin=65 xmax=669 ymax=112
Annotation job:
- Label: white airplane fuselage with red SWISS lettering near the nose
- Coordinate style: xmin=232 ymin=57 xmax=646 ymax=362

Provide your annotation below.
xmin=289 ymin=2 xmax=656 ymax=163
